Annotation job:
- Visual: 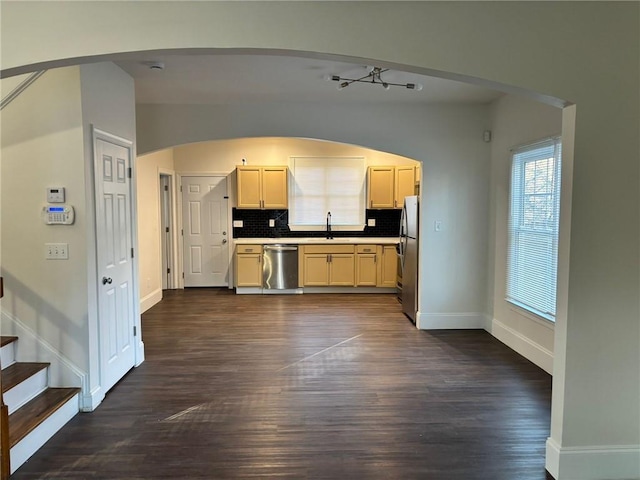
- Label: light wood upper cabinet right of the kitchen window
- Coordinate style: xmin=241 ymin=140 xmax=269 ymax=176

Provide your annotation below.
xmin=367 ymin=165 xmax=415 ymax=208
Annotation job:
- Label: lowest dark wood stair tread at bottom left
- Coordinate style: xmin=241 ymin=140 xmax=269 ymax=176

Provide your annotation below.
xmin=9 ymin=388 xmax=80 ymax=447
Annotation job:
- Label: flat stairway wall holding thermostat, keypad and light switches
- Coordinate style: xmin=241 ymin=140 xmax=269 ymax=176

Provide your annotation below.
xmin=2 ymin=67 xmax=89 ymax=386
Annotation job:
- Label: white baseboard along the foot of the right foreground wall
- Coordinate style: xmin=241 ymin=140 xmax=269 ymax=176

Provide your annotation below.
xmin=546 ymin=438 xmax=640 ymax=480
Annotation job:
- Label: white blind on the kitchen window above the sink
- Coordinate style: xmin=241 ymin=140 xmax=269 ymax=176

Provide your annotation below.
xmin=289 ymin=157 xmax=366 ymax=230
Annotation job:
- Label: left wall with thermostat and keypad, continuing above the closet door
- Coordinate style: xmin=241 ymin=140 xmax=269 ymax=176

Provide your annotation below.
xmin=1 ymin=63 xmax=140 ymax=409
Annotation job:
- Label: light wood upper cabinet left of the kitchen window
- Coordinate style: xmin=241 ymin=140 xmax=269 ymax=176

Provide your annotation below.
xmin=236 ymin=165 xmax=288 ymax=209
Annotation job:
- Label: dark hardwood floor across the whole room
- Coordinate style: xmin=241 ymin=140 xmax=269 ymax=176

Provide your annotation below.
xmin=12 ymin=289 xmax=551 ymax=480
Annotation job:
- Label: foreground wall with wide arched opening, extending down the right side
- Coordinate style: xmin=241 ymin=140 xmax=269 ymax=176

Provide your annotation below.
xmin=0 ymin=1 xmax=640 ymax=479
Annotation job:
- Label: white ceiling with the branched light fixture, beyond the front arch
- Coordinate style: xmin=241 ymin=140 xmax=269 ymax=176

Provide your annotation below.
xmin=117 ymin=55 xmax=502 ymax=105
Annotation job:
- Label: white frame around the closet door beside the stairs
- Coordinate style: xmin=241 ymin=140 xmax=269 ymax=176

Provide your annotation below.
xmin=90 ymin=125 xmax=144 ymax=411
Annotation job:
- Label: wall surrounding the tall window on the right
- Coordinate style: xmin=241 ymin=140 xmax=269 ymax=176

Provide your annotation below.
xmin=489 ymin=95 xmax=562 ymax=373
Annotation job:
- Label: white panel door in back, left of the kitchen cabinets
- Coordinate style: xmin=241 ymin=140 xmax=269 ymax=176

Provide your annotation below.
xmin=182 ymin=176 xmax=229 ymax=287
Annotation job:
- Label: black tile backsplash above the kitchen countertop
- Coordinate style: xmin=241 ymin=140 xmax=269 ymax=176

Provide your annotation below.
xmin=233 ymin=208 xmax=402 ymax=238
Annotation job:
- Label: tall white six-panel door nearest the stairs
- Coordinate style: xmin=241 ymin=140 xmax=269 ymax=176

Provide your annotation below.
xmin=94 ymin=131 xmax=135 ymax=392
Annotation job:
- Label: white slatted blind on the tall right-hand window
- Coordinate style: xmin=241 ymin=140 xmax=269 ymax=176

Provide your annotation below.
xmin=507 ymin=137 xmax=561 ymax=321
